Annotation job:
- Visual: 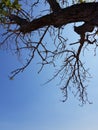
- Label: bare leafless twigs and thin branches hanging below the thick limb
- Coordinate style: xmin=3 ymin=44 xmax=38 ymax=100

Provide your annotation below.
xmin=0 ymin=0 xmax=98 ymax=104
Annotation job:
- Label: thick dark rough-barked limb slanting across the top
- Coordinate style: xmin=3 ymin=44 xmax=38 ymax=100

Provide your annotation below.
xmin=20 ymin=2 xmax=98 ymax=33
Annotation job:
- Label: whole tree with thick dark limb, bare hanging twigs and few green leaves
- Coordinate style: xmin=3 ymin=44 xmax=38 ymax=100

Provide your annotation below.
xmin=0 ymin=0 xmax=98 ymax=104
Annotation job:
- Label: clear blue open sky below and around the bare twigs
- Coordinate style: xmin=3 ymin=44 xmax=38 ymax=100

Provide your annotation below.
xmin=0 ymin=0 xmax=98 ymax=130
